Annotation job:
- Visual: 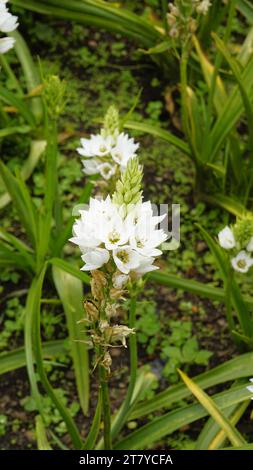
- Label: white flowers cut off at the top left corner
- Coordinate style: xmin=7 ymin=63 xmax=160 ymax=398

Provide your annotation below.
xmin=0 ymin=0 xmax=18 ymax=54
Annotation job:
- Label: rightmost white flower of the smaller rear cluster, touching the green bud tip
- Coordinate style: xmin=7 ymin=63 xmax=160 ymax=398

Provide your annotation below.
xmin=111 ymin=133 xmax=139 ymax=170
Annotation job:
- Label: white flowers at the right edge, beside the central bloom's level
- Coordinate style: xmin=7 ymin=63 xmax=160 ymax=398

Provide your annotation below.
xmin=218 ymin=226 xmax=253 ymax=273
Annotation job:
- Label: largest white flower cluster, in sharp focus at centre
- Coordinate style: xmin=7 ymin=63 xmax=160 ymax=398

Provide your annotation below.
xmin=70 ymin=196 xmax=167 ymax=280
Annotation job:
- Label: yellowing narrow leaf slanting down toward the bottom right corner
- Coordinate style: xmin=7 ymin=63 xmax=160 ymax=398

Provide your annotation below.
xmin=178 ymin=370 xmax=246 ymax=447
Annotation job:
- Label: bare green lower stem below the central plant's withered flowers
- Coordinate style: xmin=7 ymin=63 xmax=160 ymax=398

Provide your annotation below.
xmin=99 ymin=365 xmax=112 ymax=450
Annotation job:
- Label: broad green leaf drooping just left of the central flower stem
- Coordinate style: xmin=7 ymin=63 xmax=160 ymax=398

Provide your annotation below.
xmin=53 ymin=266 xmax=89 ymax=415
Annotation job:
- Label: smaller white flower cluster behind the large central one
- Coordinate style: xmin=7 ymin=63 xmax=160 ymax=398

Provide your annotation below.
xmin=77 ymin=132 xmax=139 ymax=180
